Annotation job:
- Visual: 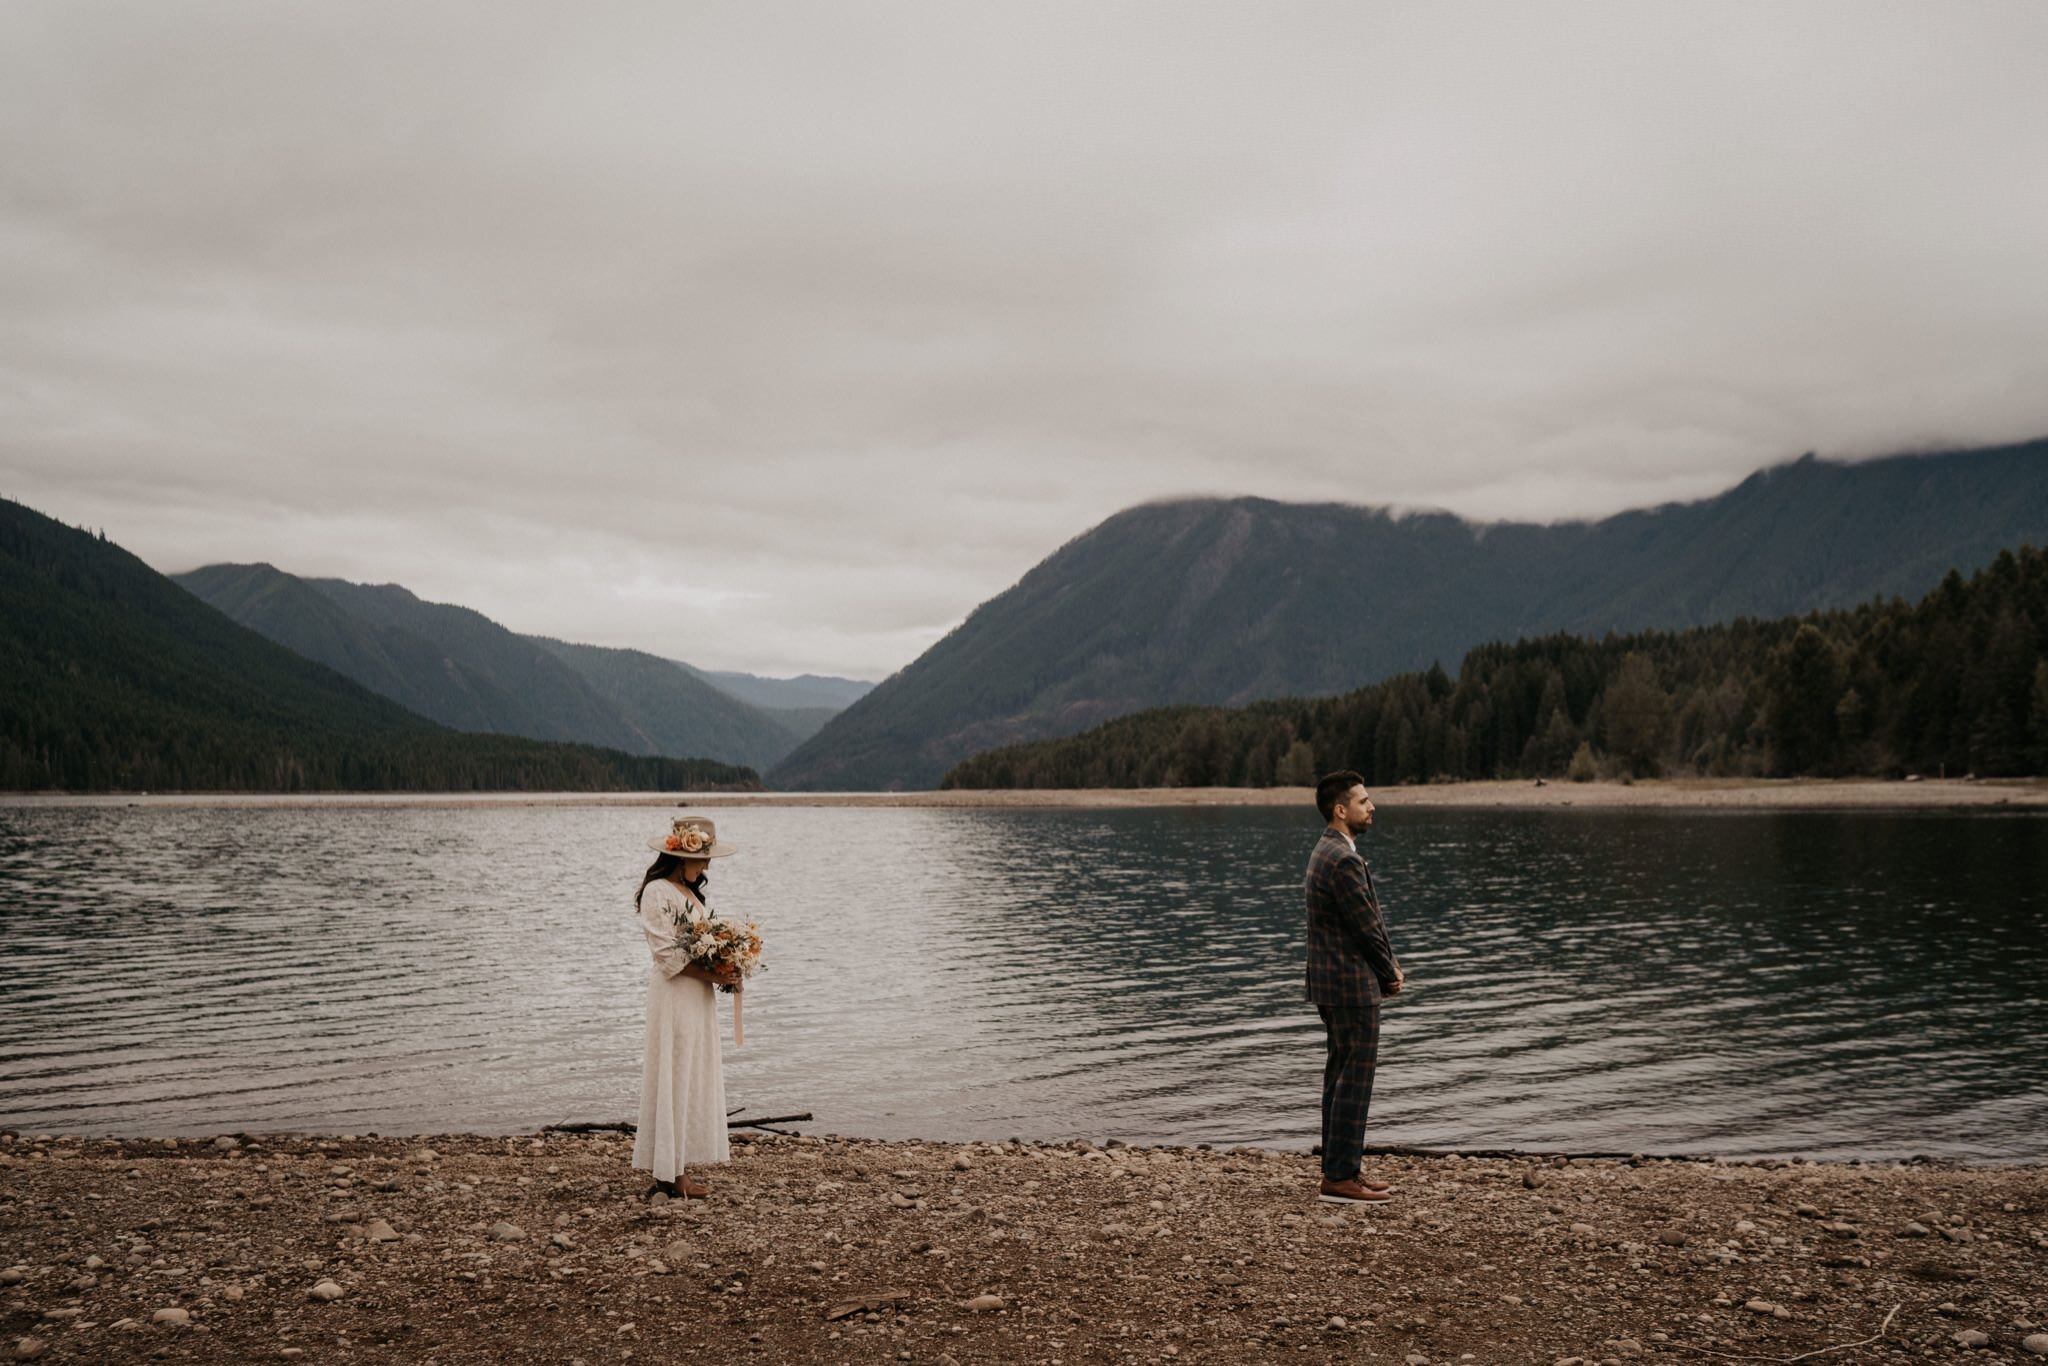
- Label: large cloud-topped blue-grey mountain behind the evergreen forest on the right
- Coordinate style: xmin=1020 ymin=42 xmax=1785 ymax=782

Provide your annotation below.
xmin=770 ymin=440 xmax=2048 ymax=791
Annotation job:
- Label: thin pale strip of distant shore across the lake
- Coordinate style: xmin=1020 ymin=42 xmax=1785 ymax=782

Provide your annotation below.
xmin=0 ymin=778 xmax=2048 ymax=811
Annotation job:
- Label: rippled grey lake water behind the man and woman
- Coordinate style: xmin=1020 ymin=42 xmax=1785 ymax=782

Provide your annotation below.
xmin=0 ymin=805 xmax=2048 ymax=1159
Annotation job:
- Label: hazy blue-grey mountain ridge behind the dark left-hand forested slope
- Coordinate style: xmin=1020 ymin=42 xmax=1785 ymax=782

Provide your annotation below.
xmin=174 ymin=565 xmax=815 ymax=768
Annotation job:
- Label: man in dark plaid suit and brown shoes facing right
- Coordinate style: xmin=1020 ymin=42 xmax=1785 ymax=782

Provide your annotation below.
xmin=1309 ymin=770 xmax=1403 ymax=1204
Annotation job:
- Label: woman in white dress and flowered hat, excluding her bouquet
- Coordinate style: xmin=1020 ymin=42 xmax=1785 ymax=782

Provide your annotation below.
xmin=633 ymin=815 xmax=739 ymax=1200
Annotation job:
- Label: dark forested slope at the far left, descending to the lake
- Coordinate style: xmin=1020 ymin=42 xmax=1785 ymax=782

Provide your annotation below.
xmin=0 ymin=500 xmax=756 ymax=793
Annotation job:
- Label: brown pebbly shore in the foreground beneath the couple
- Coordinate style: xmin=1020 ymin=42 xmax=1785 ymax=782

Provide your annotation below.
xmin=0 ymin=1133 xmax=2048 ymax=1366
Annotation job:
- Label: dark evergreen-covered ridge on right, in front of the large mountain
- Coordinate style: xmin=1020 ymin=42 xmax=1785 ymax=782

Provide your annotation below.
xmin=944 ymin=547 xmax=2048 ymax=788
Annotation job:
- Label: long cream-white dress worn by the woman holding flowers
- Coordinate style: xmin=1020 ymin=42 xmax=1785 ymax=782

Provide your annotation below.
xmin=633 ymin=879 xmax=731 ymax=1182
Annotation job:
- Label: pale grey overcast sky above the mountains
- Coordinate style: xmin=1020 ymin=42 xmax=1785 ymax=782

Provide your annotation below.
xmin=0 ymin=0 xmax=2048 ymax=678
